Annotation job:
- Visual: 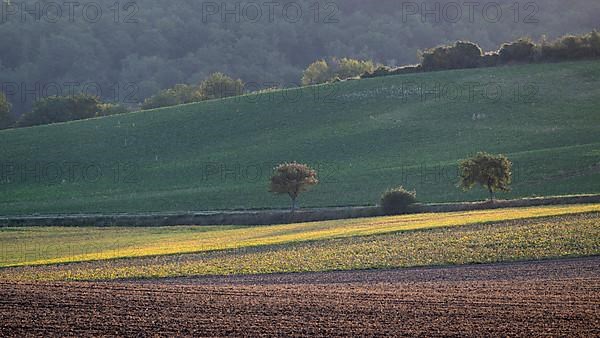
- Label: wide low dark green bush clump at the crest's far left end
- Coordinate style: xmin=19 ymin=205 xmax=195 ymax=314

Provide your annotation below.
xmin=18 ymin=94 xmax=101 ymax=127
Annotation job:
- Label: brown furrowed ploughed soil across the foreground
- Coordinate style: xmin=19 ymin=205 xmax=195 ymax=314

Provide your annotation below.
xmin=0 ymin=257 xmax=600 ymax=337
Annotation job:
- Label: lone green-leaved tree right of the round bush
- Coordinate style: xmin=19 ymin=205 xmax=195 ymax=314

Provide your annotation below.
xmin=459 ymin=152 xmax=512 ymax=201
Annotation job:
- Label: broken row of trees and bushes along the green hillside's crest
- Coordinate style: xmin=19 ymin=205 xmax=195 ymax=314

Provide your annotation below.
xmin=0 ymin=31 xmax=600 ymax=129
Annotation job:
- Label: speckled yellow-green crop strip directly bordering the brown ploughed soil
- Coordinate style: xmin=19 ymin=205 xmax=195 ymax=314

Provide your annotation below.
xmin=0 ymin=212 xmax=600 ymax=280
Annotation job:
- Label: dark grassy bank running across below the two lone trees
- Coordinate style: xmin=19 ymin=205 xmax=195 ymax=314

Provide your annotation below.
xmin=0 ymin=194 xmax=600 ymax=227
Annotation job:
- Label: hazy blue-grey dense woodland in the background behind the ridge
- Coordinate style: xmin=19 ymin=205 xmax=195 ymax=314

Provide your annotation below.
xmin=0 ymin=0 xmax=600 ymax=116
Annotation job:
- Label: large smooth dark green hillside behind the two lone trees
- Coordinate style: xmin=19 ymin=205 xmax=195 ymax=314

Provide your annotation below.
xmin=0 ymin=61 xmax=600 ymax=214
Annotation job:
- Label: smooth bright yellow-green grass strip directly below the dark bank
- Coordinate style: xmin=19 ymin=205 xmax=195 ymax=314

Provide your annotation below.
xmin=0 ymin=204 xmax=600 ymax=267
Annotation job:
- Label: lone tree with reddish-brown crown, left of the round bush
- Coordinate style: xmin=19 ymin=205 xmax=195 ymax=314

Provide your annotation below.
xmin=269 ymin=162 xmax=319 ymax=211
